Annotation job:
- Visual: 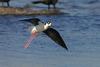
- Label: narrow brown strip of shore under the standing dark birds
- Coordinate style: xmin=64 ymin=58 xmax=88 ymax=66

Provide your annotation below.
xmin=0 ymin=7 xmax=60 ymax=15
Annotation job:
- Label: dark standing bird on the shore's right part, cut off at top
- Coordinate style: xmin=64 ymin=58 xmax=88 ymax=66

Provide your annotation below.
xmin=32 ymin=0 xmax=58 ymax=9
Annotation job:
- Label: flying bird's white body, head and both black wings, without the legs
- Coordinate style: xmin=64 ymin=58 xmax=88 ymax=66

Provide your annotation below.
xmin=21 ymin=18 xmax=68 ymax=50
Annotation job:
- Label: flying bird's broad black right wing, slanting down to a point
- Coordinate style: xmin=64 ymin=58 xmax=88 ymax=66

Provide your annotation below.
xmin=43 ymin=28 xmax=68 ymax=50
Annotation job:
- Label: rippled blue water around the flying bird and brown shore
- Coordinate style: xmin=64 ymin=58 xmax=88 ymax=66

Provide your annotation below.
xmin=0 ymin=0 xmax=100 ymax=67
